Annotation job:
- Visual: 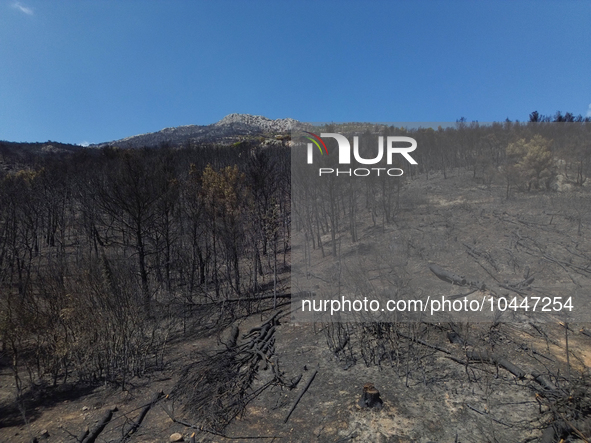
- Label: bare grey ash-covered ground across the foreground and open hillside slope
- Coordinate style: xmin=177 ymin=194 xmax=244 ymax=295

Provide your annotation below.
xmin=0 ymin=169 xmax=591 ymax=443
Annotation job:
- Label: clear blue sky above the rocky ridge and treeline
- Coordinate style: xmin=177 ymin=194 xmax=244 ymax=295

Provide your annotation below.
xmin=0 ymin=0 xmax=591 ymax=143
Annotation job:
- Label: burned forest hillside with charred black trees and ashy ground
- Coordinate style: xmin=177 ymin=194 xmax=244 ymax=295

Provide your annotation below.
xmin=0 ymin=118 xmax=591 ymax=443
